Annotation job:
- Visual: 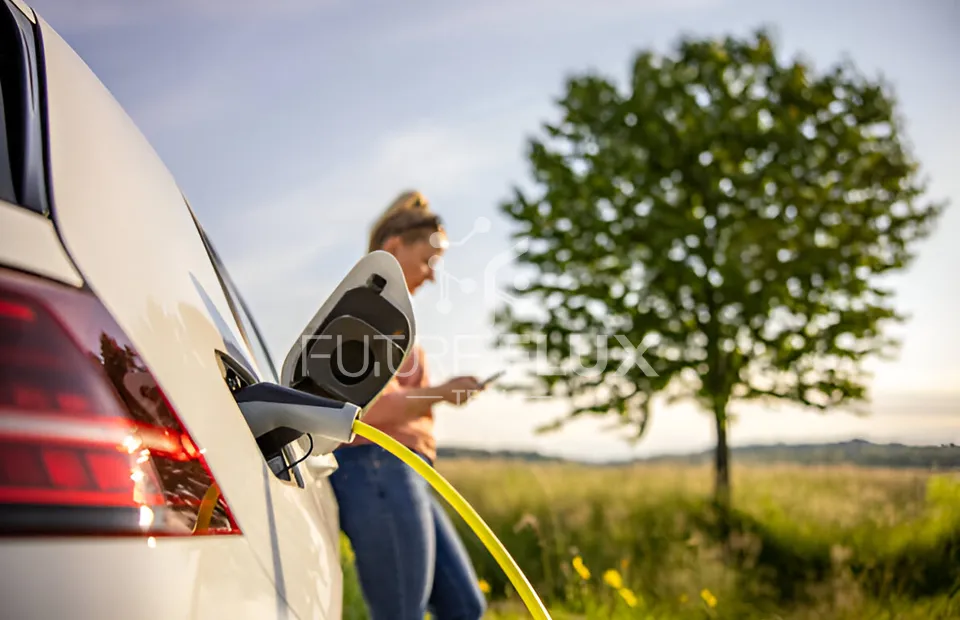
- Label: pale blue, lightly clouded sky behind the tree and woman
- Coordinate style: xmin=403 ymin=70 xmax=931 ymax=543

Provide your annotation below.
xmin=31 ymin=0 xmax=960 ymax=460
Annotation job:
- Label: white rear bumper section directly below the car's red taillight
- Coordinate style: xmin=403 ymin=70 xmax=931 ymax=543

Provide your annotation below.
xmin=0 ymin=537 xmax=290 ymax=620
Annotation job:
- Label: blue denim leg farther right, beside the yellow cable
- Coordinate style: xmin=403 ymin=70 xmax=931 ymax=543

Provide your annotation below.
xmin=430 ymin=496 xmax=487 ymax=620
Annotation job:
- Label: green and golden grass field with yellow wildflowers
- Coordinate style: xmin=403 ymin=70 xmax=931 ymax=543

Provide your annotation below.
xmin=344 ymin=459 xmax=960 ymax=620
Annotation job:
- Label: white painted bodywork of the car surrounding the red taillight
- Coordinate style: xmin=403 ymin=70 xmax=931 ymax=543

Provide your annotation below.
xmin=0 ymin=9 xmax=342 ymax=620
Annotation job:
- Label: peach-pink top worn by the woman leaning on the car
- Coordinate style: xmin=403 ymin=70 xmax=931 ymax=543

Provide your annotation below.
xmin=344 ymin=345 xmax=437 ymax=462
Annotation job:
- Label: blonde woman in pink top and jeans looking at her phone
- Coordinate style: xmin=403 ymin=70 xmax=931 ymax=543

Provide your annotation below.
xmin=331 ymin=191 xmax=486 ymax=620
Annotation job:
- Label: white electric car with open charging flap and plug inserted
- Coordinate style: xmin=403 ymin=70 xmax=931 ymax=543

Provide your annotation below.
xmin=0 ymin=0 xmax=414 ymax=620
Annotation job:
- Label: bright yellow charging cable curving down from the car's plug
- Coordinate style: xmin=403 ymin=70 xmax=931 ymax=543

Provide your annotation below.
xmin=353 ymin=420 xmax=551 ymax=620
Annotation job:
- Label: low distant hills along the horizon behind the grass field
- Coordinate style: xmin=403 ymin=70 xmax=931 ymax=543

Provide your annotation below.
xmin=438 ymin=439 xmax=960 ymax=470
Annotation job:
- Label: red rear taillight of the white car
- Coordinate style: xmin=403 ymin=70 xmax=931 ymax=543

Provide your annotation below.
xmin=0 ymin=270 xmax=240 ymax=536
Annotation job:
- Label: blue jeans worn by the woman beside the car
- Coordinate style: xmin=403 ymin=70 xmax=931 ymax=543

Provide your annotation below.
xmin=330 ymin=445 xmax=486 ymax=620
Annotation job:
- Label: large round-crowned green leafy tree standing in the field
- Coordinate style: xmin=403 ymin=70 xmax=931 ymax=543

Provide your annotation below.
xmin=495 ymin=29 xmax=946 ymax=506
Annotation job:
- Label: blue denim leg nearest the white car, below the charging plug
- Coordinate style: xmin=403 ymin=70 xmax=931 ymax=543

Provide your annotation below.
xmin=330 ymin=446 xmax=436 ymax=620
